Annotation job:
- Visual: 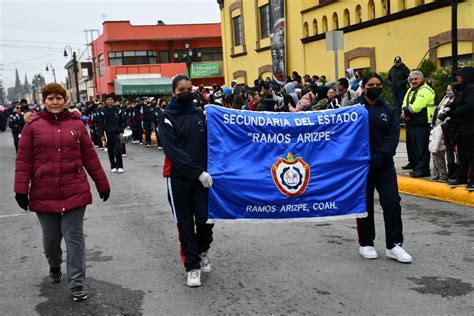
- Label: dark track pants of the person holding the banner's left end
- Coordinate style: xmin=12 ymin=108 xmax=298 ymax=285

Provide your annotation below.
xmin=168 ymin=178 xmax=214 ymax=271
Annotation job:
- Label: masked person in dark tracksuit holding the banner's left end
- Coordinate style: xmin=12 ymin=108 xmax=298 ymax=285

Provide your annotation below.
xmin=158 ymin=75 xmax=214 ymax=287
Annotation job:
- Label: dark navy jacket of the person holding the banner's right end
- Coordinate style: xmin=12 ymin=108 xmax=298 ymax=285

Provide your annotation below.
xmin=358 ymin=95 xmax=400 ymax=168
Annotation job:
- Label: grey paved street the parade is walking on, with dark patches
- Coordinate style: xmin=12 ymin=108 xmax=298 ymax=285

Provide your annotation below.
xmin=0 ymin=133 xmax=474 ymax=315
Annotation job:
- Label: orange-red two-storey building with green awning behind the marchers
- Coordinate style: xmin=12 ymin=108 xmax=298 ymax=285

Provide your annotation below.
xmin=91 ymin=21 xmax=224 ymax=98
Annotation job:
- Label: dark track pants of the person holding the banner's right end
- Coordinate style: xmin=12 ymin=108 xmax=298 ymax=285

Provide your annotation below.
xmin=356 ymin=164 xmax=403 ymax=249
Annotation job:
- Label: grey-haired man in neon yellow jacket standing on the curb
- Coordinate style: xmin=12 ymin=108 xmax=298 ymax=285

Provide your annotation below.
xmin=401 ymin=70 xmax=435 ymax=178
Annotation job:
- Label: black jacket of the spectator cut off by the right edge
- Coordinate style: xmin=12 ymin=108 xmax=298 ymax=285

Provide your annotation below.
xmin=448 ymin=67 xmax=474 ymax=137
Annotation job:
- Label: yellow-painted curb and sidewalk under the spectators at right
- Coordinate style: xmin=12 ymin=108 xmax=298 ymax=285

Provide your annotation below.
xmin=394 ymin=142 xmax=474 ymax=206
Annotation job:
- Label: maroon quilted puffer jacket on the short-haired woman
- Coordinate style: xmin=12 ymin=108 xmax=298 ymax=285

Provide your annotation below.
xmin=14 ymin=111 xmax=110 ymax=213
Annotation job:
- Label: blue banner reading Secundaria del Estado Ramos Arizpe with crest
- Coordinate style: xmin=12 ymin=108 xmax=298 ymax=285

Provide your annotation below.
xmin=206 ymin=106 xmax=370 ymax=220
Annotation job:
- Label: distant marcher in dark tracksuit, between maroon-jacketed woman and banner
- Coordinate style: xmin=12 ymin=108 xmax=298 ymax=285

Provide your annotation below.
xmin=99 ymin=95 xmax=125 ymax=173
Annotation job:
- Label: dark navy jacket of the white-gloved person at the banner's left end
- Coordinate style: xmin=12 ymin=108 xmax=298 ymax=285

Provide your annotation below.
xmin=158 ymin=98 xmax=207 ymax=180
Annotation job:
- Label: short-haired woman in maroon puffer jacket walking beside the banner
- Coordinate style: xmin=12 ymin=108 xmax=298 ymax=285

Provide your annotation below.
xmin=14 ymin=83 xmax=110 ymax=301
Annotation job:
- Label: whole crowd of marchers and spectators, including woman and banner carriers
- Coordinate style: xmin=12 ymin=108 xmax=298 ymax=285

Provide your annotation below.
xmin=2 ymin=57 xmax=474 ymax=301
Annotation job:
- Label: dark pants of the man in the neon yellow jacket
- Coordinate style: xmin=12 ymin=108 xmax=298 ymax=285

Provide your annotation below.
xmin=407 ymin=124 xmax=430 ymax=174
